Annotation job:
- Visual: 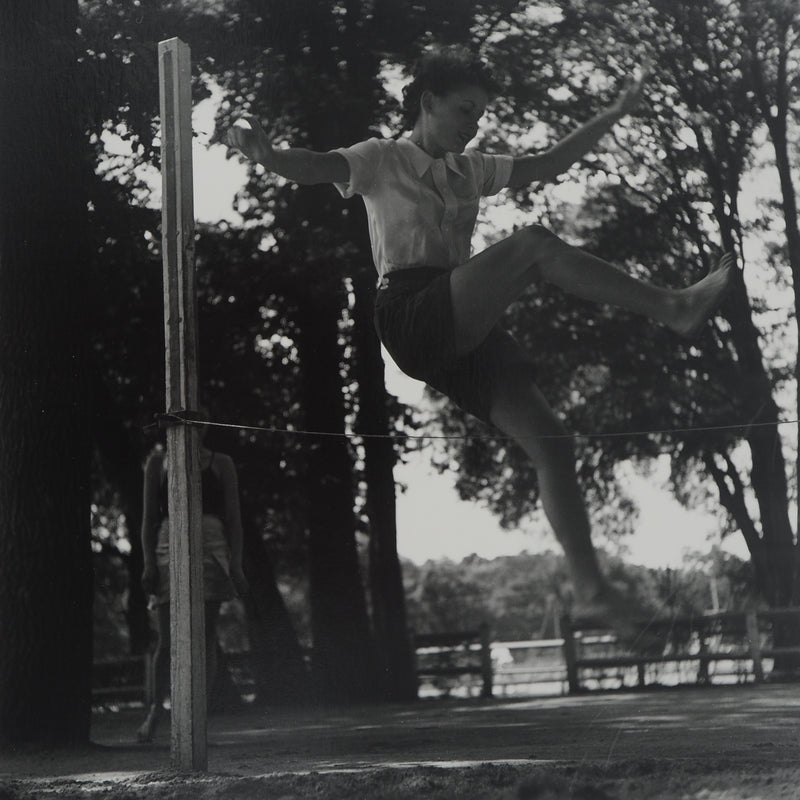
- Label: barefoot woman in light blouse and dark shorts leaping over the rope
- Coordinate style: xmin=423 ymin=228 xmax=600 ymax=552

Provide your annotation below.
xmin=227 ymin=48 xmax=734 ymax=639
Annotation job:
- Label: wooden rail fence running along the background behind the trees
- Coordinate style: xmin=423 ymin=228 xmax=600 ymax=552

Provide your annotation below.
xmin=93 ymin=608 xmax=800 ymax=704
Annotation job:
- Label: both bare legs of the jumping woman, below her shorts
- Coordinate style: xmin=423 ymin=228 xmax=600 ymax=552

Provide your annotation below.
xmin=450 ymin=226 xmax=720 ymax=640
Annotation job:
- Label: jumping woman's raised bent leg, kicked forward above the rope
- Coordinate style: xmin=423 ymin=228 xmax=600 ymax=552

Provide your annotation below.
xmin=450 ymin=226 xmax=733 ymax=353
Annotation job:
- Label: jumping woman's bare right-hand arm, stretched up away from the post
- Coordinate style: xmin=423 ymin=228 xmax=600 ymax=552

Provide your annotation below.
xmin=508 ymin=69 xmax=647 ymax=189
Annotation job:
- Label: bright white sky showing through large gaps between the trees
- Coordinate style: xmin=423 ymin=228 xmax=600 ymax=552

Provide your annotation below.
xmin=133 ymin=87 xmax=748 ymax=567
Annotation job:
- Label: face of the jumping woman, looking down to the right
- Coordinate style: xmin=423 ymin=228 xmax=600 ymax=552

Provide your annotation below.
xmin=421 ymin=86 xmax=489 ymax=157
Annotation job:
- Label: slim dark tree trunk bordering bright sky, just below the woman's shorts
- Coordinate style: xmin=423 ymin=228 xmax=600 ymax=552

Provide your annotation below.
xmin=353 ymin=274 xmax=417 ymax=700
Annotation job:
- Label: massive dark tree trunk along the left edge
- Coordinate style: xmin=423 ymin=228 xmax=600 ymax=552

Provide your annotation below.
xmin=0 ymin=0 xmax=92 ymax=744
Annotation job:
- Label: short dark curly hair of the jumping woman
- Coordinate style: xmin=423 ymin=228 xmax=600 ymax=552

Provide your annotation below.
xmin=403 ymin=45 xmax=500 ymax=129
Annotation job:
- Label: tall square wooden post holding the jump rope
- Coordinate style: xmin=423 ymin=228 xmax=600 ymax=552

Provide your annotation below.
xmin=158 ymin=39 xmax=208 ymax=770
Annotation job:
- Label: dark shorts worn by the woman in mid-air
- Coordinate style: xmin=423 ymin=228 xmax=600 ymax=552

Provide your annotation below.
xmin=375 ymin=267 xmax=535 ymax=422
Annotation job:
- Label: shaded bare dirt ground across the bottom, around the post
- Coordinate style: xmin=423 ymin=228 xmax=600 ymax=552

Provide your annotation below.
xmin=0 ymin=684 xmax=800 ymax=800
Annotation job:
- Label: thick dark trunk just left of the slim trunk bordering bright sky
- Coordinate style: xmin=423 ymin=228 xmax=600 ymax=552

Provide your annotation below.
xmin=299 ymin=288 xmax=376 ymax=702
